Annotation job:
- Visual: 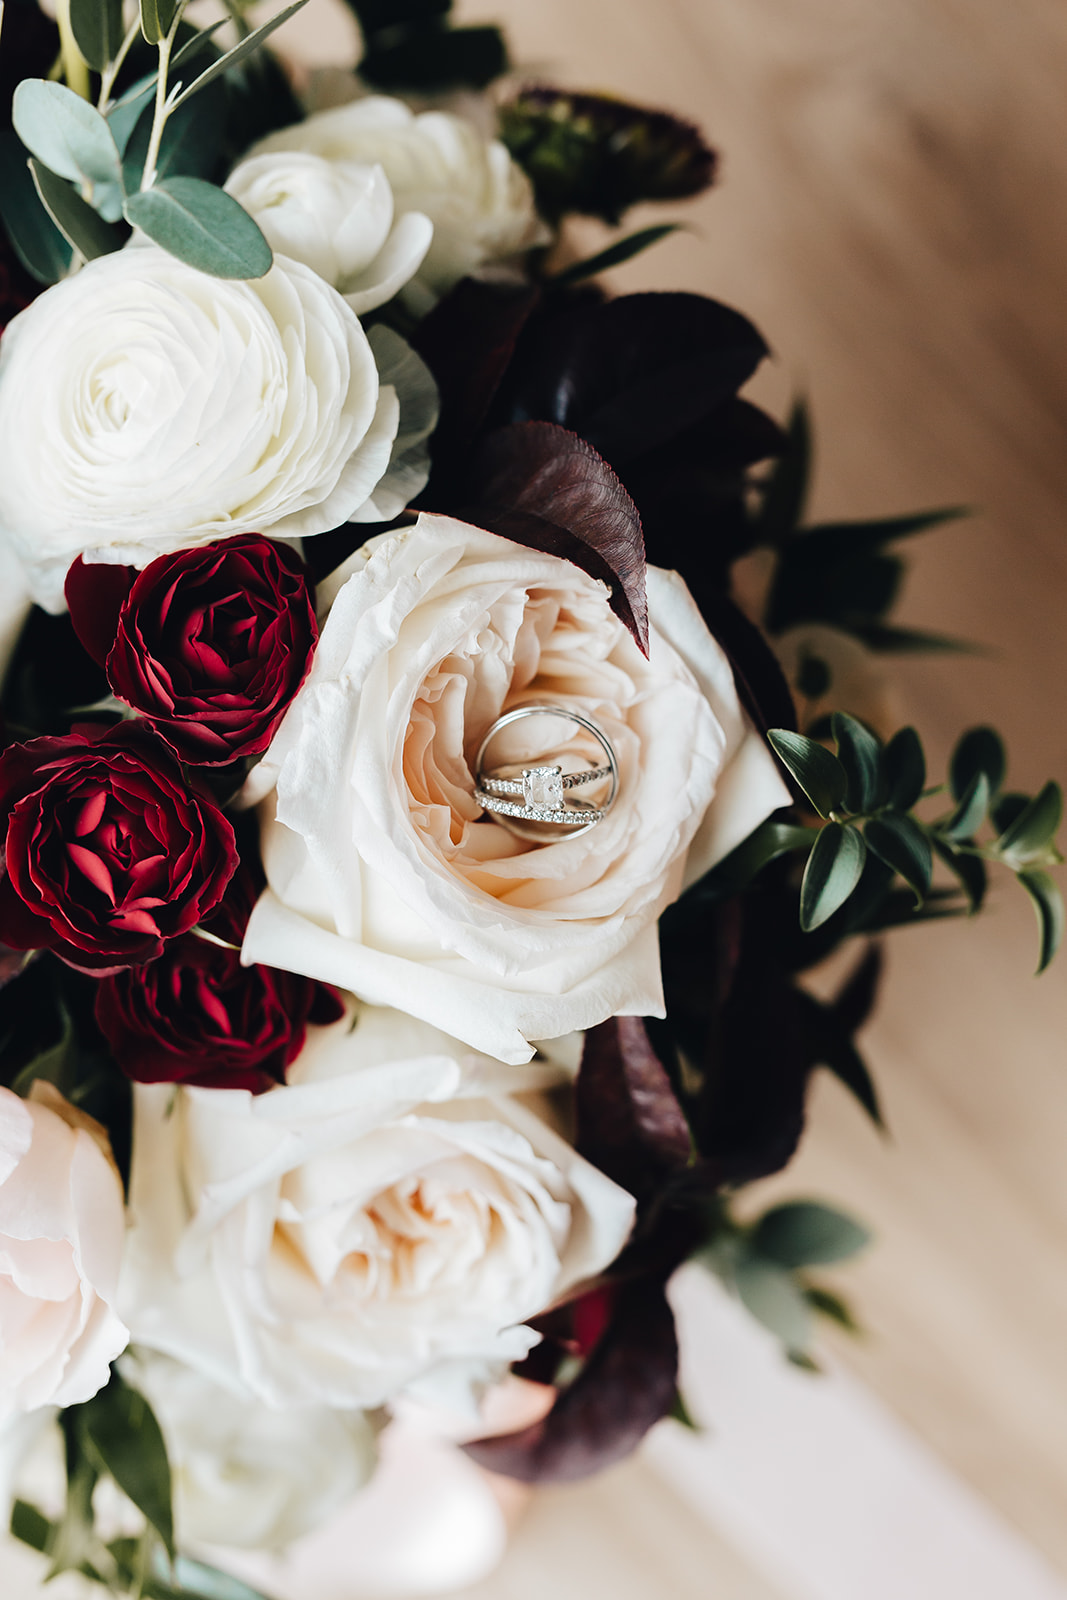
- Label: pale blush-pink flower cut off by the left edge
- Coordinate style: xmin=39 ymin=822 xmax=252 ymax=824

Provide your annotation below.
xmin=0 ymin=1082 xmax=130 ymax=1421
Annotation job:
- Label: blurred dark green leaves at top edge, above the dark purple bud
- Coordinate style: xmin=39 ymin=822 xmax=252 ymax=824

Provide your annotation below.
xmin=349 ymin=0 xmax=509 ymax=94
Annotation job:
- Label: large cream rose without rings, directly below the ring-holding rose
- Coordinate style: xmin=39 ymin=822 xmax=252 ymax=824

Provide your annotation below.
xmin=122 ymin=1008 xmax=633 ymax=1406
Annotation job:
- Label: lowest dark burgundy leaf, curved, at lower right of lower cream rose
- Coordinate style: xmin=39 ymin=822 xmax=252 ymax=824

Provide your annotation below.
xmin=464 ymin=1278 xmax=678 ymax=1483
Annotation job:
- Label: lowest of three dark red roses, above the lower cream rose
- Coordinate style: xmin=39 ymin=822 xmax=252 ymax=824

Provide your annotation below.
xmin=96 ymin=933 xmax=344 ymax=1094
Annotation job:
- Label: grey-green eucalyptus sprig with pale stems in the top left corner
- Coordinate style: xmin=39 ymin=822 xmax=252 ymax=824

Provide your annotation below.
xmin=0 ymin=0 xmax=307 ymax=283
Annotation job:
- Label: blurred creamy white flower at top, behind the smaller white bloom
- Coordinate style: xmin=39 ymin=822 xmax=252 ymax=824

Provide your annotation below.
xmin=253 ymin=94 xmax=549 ymax=312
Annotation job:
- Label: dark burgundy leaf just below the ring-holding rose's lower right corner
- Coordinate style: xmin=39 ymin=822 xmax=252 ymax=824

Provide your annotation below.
xmin=574 ymin=1016 xmax=691 ymax=1197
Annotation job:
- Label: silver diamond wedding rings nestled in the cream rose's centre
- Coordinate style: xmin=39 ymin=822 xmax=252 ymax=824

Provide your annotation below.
xmin=474 ymin=704 xmax=619 ymax=843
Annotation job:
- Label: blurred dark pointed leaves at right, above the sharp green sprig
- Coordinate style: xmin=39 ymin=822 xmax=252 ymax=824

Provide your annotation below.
xmin=749 ymin=402 xmax=973 ymax=656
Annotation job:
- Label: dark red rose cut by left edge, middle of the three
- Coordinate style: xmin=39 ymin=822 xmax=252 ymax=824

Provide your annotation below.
xmin=0 ymin=722 xmax=237 ymax=973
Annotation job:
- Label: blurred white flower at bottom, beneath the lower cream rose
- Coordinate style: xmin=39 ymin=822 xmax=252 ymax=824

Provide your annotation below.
xmin=123 ymin=1350 xmax=378 ymax=1550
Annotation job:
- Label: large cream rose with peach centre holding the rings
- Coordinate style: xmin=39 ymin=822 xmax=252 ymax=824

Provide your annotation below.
xmin=245 ymin=515 xmax=787 ymax=1062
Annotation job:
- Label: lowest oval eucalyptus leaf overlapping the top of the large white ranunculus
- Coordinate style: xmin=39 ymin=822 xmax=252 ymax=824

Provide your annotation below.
xmin=126 ymin=178 xmax=274 ymax=278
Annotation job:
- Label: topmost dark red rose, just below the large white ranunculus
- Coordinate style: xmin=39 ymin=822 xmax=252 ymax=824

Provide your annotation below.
xmin=67 ymin=533 xmax=318 ymax=766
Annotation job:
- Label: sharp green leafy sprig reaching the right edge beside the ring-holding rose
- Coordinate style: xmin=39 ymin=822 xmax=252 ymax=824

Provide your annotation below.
xmin=764 ymin=712 xmax=1064 ymax=971
